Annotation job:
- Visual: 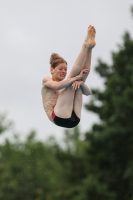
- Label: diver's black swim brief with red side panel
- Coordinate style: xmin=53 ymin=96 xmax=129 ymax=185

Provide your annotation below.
xmin=51 ymin=111 xmax=80 ymax=128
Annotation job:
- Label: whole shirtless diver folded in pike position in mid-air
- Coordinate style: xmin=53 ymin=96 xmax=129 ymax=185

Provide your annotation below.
xmin=41 ymin=25 xmax=96 ymax=128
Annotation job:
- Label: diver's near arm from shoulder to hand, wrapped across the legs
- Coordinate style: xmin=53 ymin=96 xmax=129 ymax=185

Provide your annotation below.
xmin=43 ymin=69 xmax=88 ymax=90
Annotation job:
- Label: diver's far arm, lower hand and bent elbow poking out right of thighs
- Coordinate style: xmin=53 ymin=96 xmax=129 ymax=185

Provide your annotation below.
xmin=72 ymin=81 xmax=92 ymax=96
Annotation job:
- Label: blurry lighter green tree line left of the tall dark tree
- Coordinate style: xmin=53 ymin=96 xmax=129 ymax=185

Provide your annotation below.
xmin=0 ymin=113 xmax=86 ymax=200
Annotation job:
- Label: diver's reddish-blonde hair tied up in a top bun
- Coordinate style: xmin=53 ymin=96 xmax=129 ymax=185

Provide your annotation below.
xmin=50 ymin=53 xmax=67 ymax=68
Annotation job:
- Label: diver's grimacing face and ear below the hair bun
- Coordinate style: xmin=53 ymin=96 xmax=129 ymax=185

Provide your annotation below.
xmin=50 ymin=63 xmax=67 ymax=81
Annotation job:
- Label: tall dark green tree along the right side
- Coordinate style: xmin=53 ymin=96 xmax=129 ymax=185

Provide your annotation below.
xmin=79 ymin=12 xmax=133 ymax=200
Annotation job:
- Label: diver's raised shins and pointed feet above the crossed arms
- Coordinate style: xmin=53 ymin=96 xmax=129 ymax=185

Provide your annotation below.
xmin=68 ymin=26 xmax=96 ymax=78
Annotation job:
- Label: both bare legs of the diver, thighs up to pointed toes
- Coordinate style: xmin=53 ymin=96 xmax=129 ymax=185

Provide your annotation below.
xmin=54 ymin=26 xmax=96 ymax=118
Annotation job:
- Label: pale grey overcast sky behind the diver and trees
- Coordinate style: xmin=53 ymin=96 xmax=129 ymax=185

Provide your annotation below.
xmin=0 ymin=0 xmax=133 ymax=140
